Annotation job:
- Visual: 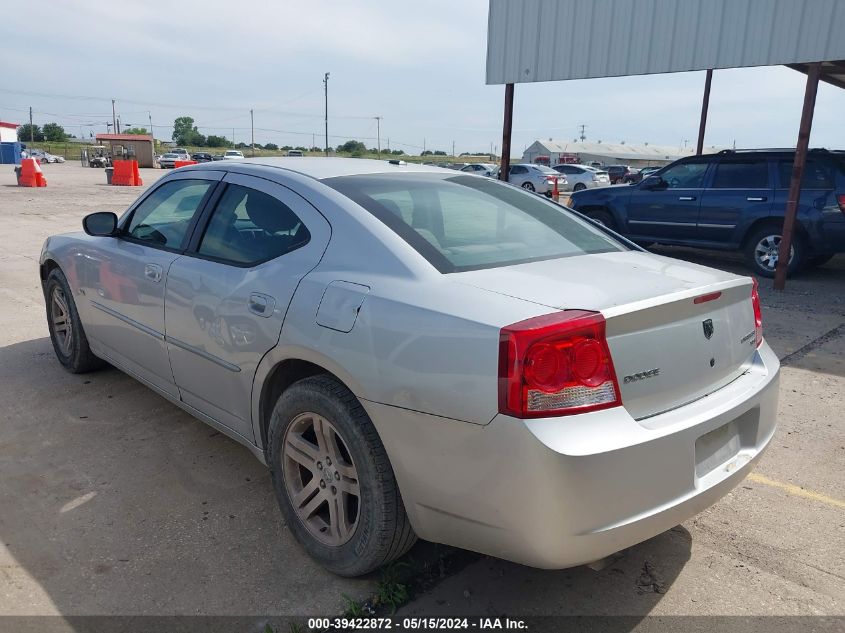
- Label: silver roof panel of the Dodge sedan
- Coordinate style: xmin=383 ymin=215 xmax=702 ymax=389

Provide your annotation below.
xmin=191 ymin=156 xmax=454 ymax=180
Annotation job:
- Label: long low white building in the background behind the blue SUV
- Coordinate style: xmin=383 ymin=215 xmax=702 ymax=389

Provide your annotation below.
xmin=522 ymin=140 xmax=722 ymax=167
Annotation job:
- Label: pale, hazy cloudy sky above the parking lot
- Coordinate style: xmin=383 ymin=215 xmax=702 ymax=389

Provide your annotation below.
xmin=0 ymin=0 xmax=845 ymax=156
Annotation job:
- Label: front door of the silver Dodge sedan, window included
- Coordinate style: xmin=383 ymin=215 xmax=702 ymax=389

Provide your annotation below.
xmin=81 ymin=170 xmax=221 ymax=395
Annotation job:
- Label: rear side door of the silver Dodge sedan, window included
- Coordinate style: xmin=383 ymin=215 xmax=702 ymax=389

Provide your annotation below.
xmin=165 ymin=174 xmax=330 ymax=440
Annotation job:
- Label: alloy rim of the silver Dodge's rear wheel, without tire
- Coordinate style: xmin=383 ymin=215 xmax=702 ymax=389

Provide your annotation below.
xmin=282 ymin=412 xmax=361 ymax=547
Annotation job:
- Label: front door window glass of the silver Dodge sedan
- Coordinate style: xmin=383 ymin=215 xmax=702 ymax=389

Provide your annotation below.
xmin=123 ymin=180 xmax=214 ymax=249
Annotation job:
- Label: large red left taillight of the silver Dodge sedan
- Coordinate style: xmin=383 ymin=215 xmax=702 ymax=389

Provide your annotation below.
xmin=499 ymin=310 xmax=622 ymax=418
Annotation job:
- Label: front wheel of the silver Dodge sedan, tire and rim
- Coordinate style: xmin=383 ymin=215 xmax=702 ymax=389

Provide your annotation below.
xmin=44 ymin=268 xmax=106 ymax=374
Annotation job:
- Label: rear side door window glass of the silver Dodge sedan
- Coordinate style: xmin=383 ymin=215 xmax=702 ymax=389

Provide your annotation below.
xmin=197 ymin=185 xmax=311 ymax=266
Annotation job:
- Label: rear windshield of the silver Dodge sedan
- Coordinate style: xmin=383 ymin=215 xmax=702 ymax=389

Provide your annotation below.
xmin=323 ymin=173 xmax=628 ymax=273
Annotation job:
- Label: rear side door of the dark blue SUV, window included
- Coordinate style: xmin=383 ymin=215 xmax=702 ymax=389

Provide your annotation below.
xmin=698 ymin=156 xmax=774 ymax=244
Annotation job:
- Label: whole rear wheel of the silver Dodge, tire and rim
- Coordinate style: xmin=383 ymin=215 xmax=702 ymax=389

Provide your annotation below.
xmin=267 ymin=375 xmax=417 ymax=577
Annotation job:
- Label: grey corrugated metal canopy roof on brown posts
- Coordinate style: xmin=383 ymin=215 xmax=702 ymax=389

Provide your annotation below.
xmin=487 ymin=0 xmax=845 ymax=87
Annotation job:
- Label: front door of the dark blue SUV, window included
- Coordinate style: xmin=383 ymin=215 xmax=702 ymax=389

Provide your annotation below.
xmin=626 ymin=159 xmax=710 ymax=241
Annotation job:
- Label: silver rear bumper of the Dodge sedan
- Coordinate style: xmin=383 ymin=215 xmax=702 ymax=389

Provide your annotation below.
xmin=365 ymin=343 xmax=779 ymax=568
